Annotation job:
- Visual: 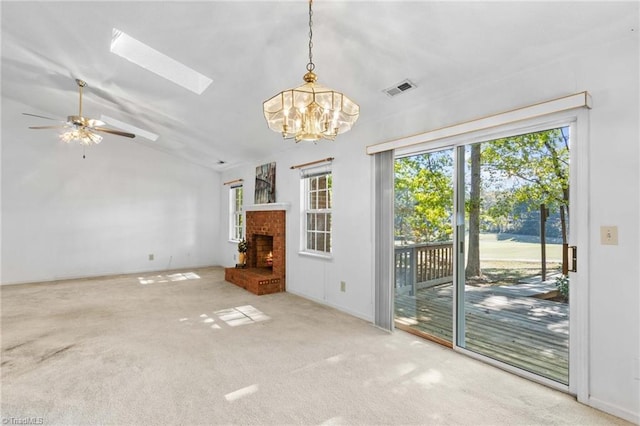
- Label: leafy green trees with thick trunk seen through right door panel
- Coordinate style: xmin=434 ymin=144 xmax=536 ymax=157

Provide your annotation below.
xmin=465 ymin=127 xmax=569 ymax=277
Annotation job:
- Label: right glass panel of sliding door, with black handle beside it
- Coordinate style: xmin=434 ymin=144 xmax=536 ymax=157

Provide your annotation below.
xmin=456 ymin=127 xmax=569 ymax=384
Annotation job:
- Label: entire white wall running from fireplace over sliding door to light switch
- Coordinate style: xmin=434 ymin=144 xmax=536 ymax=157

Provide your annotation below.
xmin=220 ymin=10 xmax=640 ymax=422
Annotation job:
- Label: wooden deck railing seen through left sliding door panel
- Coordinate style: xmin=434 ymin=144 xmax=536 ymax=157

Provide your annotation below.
xmin=395 ymin=241 xmax=453 ymax=296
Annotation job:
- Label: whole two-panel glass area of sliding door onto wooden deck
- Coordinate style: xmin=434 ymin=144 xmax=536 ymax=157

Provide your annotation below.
xmin=394 ymin=127 xmax=570 ymax=384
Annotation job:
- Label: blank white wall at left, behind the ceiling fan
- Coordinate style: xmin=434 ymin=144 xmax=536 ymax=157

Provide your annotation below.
xmin=1 ymin=101 xmax=220 ymax=284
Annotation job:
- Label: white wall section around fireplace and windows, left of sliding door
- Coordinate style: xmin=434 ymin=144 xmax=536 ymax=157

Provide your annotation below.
xmin=219 ymin=139 xmax=373 ymax=320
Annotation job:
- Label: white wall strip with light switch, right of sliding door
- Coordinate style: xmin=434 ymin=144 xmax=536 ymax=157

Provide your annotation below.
xmin=581 ymin=37 xmax=640 ymax=423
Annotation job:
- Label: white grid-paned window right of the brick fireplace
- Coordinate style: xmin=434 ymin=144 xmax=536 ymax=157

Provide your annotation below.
xmin=302 ymin=167 xmax=333 ymax=255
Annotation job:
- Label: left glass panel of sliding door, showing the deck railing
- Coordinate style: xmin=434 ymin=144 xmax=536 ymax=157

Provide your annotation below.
xmin=394 ymin=148 xmax=454 ymax=346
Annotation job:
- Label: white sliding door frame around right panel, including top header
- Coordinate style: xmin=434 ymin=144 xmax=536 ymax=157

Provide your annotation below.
xmin=390 ymin=105 xmax=590 ymax=402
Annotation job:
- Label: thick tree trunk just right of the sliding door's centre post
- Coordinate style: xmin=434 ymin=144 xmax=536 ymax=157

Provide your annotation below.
xmin=465 ymin=143 xmax=482 ymax=278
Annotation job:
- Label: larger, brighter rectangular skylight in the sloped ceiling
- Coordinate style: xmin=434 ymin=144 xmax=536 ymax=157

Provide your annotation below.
xmin=111 ymin=28 xmax=212 ymax=95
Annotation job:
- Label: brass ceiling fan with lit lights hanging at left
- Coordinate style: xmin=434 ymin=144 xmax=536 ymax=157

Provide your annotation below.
xmin=22 ymin=79 xmax=136 ymax=145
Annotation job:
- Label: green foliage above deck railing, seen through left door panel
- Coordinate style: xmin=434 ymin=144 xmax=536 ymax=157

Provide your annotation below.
xmin=394 ymin=151 xmax=453 ymax=243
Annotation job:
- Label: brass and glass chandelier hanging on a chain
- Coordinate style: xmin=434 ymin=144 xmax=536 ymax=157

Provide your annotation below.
xmin=263 ymin=0 xmax=360 ymax=142
